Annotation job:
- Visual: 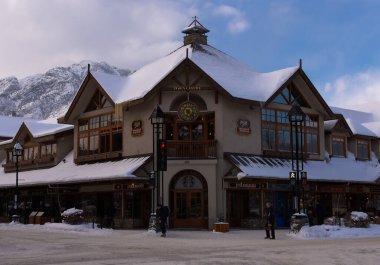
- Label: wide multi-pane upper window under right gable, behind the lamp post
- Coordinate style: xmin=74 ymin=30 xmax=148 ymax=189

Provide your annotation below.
xmin=261 ymin=109 xmax=320 ymax=154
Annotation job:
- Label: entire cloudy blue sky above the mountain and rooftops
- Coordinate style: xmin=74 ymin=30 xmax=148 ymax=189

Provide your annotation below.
xmin=0 ymin=0 xmax=380 ymax=106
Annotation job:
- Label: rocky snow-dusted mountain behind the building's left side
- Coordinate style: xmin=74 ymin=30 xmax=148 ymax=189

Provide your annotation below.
xmin=0 ymin=61 xmax=131 ymax=119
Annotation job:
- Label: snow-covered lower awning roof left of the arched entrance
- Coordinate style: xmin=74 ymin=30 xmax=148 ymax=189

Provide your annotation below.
xmin=0 ymin=151 xmax=149 ymax=188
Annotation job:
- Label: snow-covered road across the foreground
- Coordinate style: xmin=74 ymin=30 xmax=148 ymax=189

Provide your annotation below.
xmin=0 ymin=227 xmax=380 ymax=265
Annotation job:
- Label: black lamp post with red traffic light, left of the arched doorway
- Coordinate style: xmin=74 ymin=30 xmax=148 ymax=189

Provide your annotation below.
xmin=149 ymin=105 xmax=164 ymax=231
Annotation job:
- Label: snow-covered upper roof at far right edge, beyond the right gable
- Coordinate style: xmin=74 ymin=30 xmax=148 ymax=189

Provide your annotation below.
xmin=331 ymin=107 xmax=380 ymax=137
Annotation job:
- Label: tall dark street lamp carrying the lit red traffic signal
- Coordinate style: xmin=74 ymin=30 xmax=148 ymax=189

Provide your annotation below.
xmin=149 ymin=105 xmax=166 ymax=231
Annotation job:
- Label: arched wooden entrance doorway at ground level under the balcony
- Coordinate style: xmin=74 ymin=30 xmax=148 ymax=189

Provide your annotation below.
xmin=170 ymin=170 xmax=208 ymax=228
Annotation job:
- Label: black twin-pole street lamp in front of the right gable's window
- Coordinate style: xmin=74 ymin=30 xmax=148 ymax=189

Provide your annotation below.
xmin=288 ymin=103 xmax=305 ymax=213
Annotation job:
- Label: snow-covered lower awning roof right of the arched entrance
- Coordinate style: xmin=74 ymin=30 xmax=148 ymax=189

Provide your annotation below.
xmin=228 ymin=153 xmax=380 ymax=182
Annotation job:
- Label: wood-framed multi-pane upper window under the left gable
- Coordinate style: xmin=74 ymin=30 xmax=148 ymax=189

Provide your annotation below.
xmin=78 ymin=113 xmax=123 ymax=156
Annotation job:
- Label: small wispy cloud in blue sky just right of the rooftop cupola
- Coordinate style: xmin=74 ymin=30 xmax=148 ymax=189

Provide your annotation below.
xmin=214 ymin=5 xmax=249 ymax=33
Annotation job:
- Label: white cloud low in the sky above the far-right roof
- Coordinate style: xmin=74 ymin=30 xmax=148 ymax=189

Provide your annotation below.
xmin=324 ymin=69 xmax=380 ymax=108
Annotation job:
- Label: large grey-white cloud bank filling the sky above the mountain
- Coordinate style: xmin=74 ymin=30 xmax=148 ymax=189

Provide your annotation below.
xmin=0 ymin=0 xmax=190 ymax=78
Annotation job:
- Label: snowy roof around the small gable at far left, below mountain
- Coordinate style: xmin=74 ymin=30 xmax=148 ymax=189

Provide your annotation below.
xmin=0 ymin=116 xmax=74 ymax=146
